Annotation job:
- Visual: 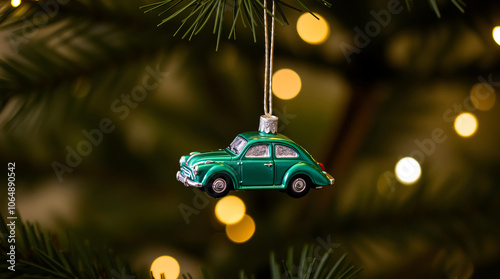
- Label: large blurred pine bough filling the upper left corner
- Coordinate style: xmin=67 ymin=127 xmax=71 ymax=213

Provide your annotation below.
xmin=0 ymin=1 xmax=174 ymax=135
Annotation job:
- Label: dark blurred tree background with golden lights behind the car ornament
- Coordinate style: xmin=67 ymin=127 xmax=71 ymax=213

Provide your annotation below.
xmin=0 ymin=0 xmax=500 ymax=278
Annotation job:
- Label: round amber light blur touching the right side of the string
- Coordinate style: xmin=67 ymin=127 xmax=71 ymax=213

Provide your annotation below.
xmin=272 ymin=69 xmax=302 ymax=100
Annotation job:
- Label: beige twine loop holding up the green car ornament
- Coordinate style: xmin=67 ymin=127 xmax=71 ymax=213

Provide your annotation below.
xmin=264 ymin=0 xmax=275 ymax=116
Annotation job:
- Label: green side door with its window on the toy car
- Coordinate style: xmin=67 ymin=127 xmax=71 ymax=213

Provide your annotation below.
xmin=240 ymin=143 xmax=274 ymax=186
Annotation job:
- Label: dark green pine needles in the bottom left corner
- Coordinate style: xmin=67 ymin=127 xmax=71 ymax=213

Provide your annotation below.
xmin=0 ymin=214 xmax=135 ymax=279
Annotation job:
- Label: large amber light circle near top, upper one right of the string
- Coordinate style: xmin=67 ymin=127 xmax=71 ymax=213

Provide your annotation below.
xmin=297 ymin=13 xmax=330 ymax=45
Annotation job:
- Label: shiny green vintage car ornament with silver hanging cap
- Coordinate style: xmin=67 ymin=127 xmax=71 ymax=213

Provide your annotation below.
xmin=176 ymin=115 xmax=334 ymax=198
